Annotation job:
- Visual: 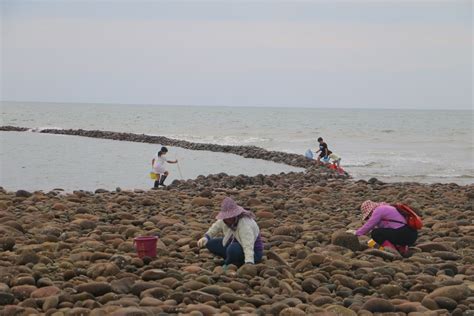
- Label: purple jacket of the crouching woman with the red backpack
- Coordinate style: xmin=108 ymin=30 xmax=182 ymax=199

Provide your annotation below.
xmin=356 ymin=205 xmax=407 ymax=236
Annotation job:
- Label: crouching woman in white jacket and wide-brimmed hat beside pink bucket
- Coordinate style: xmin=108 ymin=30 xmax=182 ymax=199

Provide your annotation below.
xmin=198 ymin=197 xmax=263 ymax=268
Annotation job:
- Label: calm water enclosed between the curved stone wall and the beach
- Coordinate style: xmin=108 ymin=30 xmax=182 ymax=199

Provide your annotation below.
xmin=0 ymin=132 xmax=303 ymax=191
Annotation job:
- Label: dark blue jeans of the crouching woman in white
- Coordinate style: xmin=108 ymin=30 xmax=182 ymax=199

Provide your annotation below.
xmin=206 ymin=238 xmax=263 ymax=266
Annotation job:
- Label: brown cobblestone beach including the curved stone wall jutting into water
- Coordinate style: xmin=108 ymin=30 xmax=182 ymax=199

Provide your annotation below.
xmin=0 ymin=127 xmax=474 ymax=316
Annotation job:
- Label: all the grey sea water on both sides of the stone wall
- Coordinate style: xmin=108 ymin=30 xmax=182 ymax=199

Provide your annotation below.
xmin=0 ymin=102 xmax=474 ymax=190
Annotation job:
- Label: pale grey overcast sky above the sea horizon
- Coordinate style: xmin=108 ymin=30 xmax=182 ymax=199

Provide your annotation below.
xmin=0 ymin=0 xmax=473 ymax=109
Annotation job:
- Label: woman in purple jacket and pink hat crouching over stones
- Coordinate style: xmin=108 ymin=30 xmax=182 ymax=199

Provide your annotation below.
xmin=349 ymin=200 xmax=418 ymax=254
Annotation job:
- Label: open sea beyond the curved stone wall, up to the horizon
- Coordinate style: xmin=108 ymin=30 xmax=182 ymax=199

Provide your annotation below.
xmin=1 ymin=102 xmax=474 ymax=184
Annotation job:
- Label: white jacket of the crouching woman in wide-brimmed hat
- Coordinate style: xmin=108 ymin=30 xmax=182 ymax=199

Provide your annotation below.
xmin=206 ymin=217 xmax=260 ymax=263
